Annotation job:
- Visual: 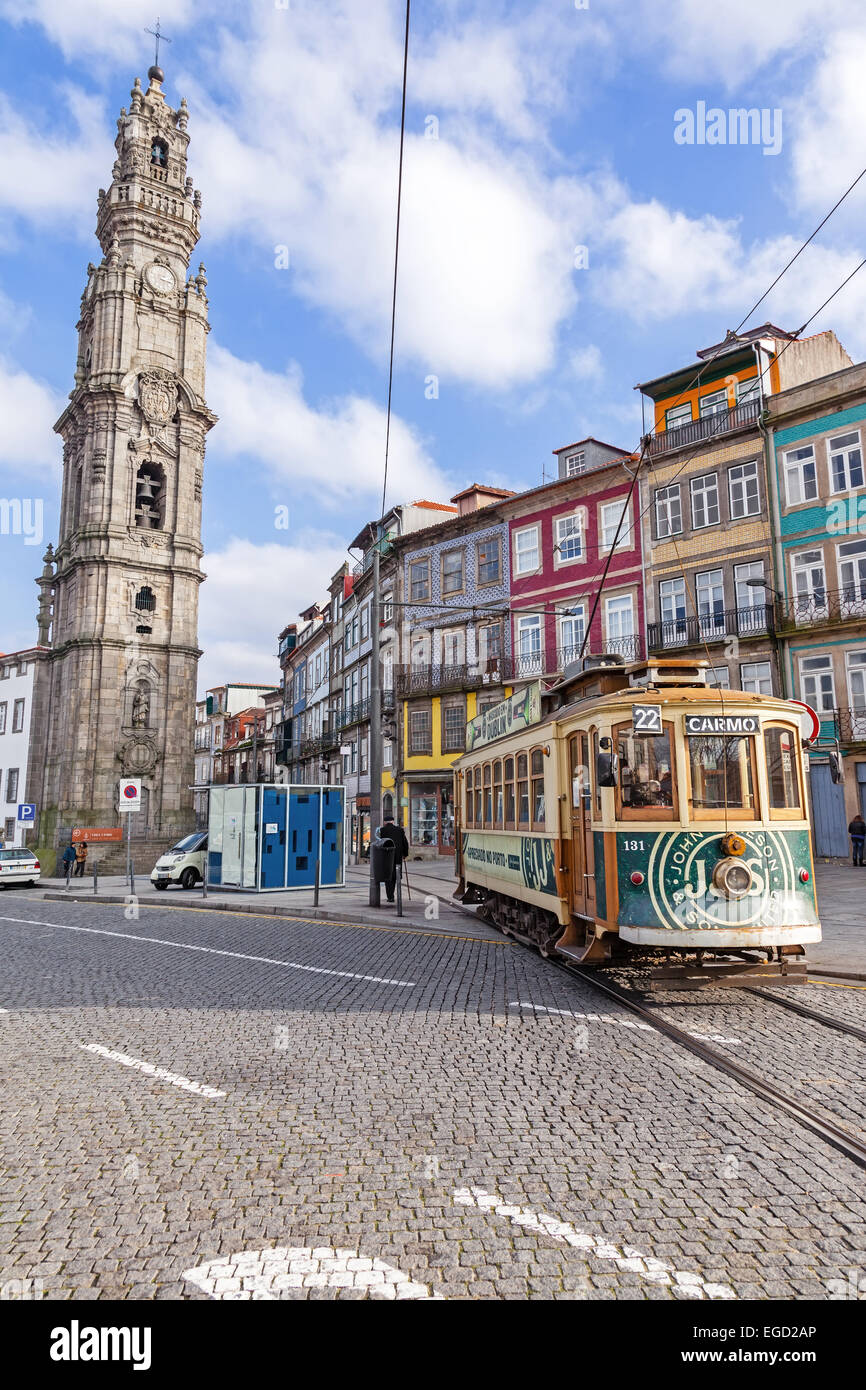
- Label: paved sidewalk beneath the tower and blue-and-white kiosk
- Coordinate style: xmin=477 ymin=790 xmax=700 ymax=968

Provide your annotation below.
xmin=28 ymin=863 xmax=503 ymax=942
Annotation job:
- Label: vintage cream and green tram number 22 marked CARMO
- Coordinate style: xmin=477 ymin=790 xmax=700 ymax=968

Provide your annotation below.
xmin=455 ymin=656 xmax=820 ymax=988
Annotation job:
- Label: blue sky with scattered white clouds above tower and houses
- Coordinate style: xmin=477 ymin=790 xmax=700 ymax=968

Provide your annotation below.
xmin=0 ymin=0 xmax=866 ymax=689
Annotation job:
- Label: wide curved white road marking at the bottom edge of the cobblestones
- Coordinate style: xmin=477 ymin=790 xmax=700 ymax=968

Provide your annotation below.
xmin=183 ymin=1245 xmax=442 ymax=1302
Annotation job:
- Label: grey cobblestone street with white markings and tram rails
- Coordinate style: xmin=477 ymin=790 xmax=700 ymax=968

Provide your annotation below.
xmin=0 ymin=892 xmax=866 ymax=1300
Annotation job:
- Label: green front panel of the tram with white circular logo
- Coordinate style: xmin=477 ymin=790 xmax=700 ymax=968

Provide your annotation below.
xmin=646 ymin=826 xmax=799 ymax=931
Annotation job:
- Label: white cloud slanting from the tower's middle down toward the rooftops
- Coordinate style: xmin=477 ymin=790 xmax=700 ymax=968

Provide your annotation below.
xmin=207 ymin=345 xmax=455 ymax=508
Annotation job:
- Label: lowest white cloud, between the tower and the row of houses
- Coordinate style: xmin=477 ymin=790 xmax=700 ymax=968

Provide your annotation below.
xmin=199 ymin=530 xmax=349 ymax=691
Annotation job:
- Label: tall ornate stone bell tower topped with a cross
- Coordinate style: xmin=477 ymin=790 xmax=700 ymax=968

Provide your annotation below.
xmin=28 ymin=65 xmax=215 ymax=872
